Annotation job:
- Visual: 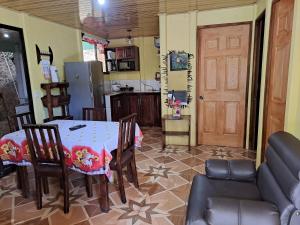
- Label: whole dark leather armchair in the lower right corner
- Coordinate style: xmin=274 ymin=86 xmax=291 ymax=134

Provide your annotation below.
xmin=186 ymin=132 xmax=300 ymax=225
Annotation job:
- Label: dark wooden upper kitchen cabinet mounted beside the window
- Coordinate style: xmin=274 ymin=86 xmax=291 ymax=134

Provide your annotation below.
xmin=105 ymin=46 xmax=140 ymax=72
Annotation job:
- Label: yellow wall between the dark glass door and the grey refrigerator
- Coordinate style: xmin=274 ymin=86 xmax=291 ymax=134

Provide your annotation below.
xmin=0 ymin=7 xmax=82 ymax=122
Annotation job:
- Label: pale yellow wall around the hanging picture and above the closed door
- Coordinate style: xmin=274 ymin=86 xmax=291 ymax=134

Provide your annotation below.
xmin=160 ymin=5 xmax=255 ymax=145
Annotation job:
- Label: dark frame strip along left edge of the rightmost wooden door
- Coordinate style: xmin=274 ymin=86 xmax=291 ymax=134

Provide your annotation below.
xmin=260 ymin=0 xmax=295 ymax=163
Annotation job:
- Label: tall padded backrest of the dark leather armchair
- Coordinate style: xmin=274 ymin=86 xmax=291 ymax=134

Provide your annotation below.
xmin=257 ymin=131 xmax=300 ymax=225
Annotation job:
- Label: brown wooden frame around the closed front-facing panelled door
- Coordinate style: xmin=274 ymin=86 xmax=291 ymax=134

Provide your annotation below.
xmin=195 ymin=21 xmax=253 ymax=148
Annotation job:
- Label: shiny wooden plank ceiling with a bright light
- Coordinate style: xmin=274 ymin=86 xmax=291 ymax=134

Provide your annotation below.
xmin=0 ymin=0 xmax=256 ymax=39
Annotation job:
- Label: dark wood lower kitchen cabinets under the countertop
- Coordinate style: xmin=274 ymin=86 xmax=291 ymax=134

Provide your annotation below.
xmin=111 ymin=93 xmax=161 ymax=126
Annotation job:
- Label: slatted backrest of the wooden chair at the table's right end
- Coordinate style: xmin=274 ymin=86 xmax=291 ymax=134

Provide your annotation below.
xmin=117 ymin=113 xmax=137 ymax=163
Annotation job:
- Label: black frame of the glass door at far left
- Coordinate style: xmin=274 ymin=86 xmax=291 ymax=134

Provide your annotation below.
xmin=0 ymin=23 xmax=35 ymax=123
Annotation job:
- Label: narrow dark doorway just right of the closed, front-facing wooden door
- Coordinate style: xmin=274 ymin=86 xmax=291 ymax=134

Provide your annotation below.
xmin=249 ymin=10 xmax=266 ymax=151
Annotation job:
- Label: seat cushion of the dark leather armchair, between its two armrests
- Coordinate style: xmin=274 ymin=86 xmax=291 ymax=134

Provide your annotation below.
xmin=186 ymin=175 xmax=260 ymax=225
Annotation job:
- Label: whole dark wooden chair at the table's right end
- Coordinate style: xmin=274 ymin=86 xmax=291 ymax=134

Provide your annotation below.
xmin=110 ymin=113 xmax=139 ymax=203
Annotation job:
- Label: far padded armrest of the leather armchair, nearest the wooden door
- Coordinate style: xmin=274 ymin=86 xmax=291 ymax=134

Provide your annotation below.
xmin=205 ymin=159 xmax=256 ymax=182
